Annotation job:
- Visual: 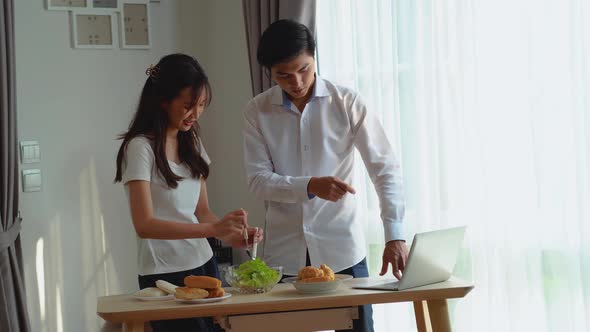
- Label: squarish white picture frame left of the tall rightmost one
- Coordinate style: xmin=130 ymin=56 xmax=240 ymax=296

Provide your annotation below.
xmin=70 ymin=8 xmax=117 ymax=49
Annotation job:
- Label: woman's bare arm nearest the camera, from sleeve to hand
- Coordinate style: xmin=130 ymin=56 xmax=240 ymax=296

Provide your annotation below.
xmin=127 ymin=180 xmax=244 ymax=240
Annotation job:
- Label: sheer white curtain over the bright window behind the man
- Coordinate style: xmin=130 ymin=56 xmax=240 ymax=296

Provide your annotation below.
xmin=317 ymin=0 xmax=590 ymax=332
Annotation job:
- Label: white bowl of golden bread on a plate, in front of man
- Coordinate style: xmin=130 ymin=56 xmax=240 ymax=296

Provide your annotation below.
xmin=282 ymin=264 xmax=353 ymax=294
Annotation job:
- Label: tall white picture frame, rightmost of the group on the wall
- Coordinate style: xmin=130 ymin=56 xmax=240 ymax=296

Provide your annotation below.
xmin=119 ymin=0 xmax=152 ymax=49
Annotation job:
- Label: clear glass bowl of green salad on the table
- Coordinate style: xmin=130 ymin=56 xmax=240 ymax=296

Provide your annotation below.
xmin=222 ymin=265 xmax=283 ymax=294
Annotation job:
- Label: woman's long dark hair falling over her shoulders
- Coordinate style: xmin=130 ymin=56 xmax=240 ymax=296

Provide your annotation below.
xmin=115 ymin=54 xmax=211 ymax=188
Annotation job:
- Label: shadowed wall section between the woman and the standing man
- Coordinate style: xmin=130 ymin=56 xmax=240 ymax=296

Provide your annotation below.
xmin=180 ymin=0 xmax=264 ymax=236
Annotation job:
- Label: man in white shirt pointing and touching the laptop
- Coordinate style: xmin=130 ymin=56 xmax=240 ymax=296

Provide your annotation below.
xmin=244 ymin=20 xmax=408 ymax=331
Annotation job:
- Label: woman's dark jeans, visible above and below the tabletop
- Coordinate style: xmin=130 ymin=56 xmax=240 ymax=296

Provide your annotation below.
xmin=137 ymin=257 xmax=223 ymax=332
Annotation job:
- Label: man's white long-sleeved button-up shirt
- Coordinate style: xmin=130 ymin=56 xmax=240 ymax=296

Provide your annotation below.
xmin=244 ymin=76 xmax=404 ymax=275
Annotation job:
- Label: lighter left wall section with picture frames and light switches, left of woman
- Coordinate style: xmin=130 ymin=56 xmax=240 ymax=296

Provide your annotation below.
xmin=14 ymin=0 xmax=184 ymax=332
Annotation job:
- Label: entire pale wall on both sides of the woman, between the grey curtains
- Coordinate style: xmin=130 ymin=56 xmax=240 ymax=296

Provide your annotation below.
xmin=15 ymin=0 xmax=263 ymax=331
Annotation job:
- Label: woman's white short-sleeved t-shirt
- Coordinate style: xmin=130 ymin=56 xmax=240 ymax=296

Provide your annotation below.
xmin=121 ymin=136 xmax=213 ymax=275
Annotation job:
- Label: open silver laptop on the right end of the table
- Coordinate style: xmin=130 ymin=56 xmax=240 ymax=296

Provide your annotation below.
xmin=353 ymin=226 xmax=465 ymax=291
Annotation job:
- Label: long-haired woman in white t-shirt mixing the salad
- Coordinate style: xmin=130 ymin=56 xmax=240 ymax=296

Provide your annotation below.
xmin=115 ymin=54 xmax=262 ymax=331
